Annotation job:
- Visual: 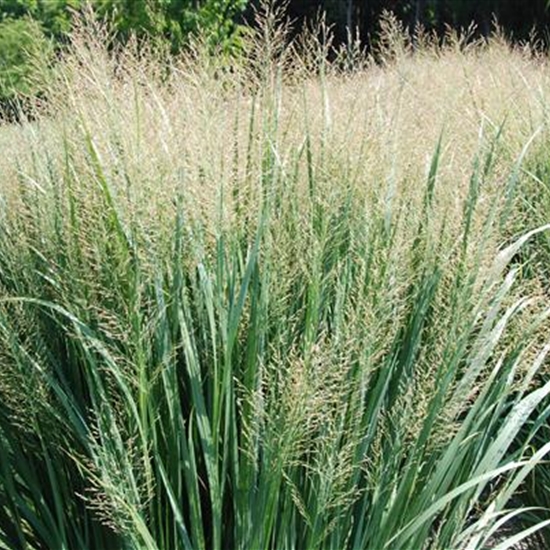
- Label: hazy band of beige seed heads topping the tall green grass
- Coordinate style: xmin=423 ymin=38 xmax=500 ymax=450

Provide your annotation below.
xmin=0 ymin=21 xmax=549 ymax=233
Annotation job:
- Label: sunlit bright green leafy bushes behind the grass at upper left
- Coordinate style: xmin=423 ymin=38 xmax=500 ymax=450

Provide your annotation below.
xmin=0 ymin=0 xmax=247 ymax=110
